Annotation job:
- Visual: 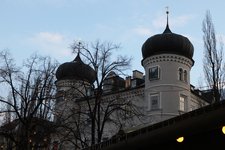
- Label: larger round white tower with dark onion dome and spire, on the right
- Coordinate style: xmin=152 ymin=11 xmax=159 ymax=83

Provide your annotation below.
xmin=142 ymin=12 xmax=194 ymax=122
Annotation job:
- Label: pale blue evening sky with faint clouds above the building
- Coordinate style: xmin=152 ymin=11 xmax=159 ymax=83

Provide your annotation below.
xmin=0 ymin=0 xmax=225 ymax=86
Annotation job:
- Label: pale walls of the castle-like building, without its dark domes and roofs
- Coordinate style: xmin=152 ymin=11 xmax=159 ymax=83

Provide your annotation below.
xmin=53 ymin=67 xmax=207 ymax=150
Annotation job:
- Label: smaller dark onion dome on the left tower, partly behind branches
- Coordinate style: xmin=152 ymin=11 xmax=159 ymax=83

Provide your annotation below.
xmin=56 ymin=53 xmax=96 ymax=83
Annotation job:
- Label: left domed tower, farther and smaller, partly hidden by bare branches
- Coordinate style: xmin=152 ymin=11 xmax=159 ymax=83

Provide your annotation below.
xmin=53 ymin=52 xmax=96 ymax=149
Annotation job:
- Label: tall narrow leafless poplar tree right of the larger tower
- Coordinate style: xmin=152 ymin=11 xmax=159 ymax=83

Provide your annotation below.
xmin=202 ymin=10 xmax=224 ymax=102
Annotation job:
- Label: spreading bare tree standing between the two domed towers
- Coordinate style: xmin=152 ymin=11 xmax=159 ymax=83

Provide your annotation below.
xmin=53 ymin=41 xmax=140 ymax=147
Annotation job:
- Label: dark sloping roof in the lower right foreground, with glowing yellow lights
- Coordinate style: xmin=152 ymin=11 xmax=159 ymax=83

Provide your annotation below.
xmin=83 ymin=101 xmax=225 ymax=150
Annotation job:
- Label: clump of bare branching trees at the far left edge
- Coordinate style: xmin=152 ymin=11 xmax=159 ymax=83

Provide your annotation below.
xmin=0 ymin=51 xmax=57 ymax=150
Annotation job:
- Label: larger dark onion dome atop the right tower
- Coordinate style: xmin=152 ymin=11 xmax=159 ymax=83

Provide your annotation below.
xmin=142 ymin=24 xmax=194 ymax=60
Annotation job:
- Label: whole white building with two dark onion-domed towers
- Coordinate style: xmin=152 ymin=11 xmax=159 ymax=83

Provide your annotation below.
xmin=55 ymin=12 xmax=210 ymax=149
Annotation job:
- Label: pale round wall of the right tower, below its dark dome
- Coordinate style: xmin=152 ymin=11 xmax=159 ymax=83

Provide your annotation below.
xmin=143 ymin=54 xmax=197 ymax=122
